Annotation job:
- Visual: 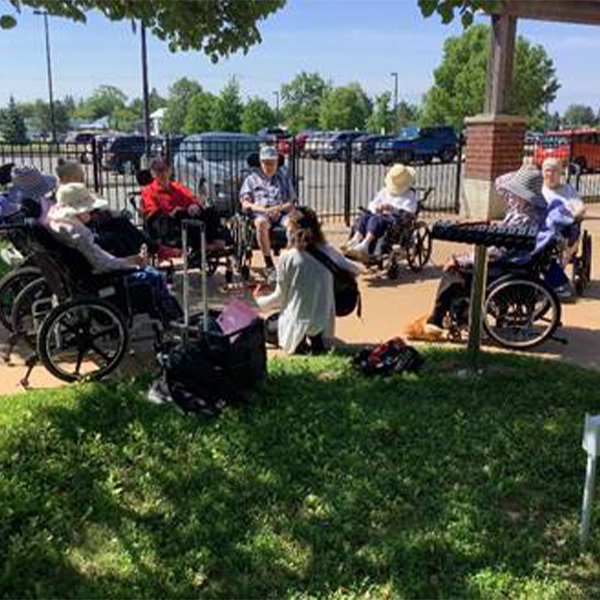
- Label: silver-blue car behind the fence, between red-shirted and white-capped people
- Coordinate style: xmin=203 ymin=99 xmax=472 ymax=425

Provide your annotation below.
xmin=173 ymin=132 xmax=262 ymax=214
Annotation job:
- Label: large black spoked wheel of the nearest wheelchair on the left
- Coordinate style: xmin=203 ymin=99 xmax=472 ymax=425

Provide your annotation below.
xmin=37 ymin=298 xmax=129 ymax=382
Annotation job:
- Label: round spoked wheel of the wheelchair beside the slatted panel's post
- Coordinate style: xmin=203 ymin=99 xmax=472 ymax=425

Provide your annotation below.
xmin=484 ymin=278 xmax=561 ymax=350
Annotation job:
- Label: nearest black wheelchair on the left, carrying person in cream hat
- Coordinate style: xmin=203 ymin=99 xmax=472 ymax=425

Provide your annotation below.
xmin=0 ymin=221 xmax=169 ymax=387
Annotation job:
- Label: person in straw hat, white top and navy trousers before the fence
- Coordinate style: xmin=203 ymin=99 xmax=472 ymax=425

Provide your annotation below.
xmin=342 ymin=164 xmax=418 ymax=264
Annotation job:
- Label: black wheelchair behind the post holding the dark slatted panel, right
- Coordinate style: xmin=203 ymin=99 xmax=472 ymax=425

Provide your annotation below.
xmin=444 ymin=244 xmax=566 ymax=350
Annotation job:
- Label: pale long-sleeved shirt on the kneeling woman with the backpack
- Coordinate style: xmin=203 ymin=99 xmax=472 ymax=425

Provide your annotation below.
xmin=256 ymin=244 xmax=360 ymax=353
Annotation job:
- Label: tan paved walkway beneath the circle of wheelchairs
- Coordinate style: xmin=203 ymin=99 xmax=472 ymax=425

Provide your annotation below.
xmin=0 ymin=206 xmax=600 ymax=395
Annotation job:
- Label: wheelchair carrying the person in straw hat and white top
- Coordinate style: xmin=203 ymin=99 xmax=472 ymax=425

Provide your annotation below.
xmin=350 ymin=187 xmax=434 ymax=279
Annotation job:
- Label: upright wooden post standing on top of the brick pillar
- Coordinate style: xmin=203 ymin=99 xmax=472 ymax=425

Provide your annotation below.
xmin=484 ymin=14 xmax=517 ymax=115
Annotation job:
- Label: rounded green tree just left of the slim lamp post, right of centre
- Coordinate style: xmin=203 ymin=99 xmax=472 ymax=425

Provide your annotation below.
xmin=319 ymin=83 xmax=371 ymax=129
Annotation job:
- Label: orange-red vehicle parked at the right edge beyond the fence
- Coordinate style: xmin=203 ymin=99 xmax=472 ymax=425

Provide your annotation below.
xmin=533 ymin=128 xmax=600 ymax=172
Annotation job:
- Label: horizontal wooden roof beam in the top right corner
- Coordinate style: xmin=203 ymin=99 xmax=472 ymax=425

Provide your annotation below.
xmin=499 ymin=0 xmax=600 ymax=25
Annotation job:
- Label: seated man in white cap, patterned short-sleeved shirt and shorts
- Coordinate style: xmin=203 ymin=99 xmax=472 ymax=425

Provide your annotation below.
xmin=240 ymin=145 xmax=297 ymax=283
